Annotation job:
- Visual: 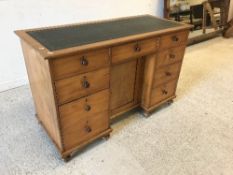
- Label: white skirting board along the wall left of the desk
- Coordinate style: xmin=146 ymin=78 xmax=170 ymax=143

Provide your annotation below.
xmin=0 ymin=77 xmax=28 ymax=92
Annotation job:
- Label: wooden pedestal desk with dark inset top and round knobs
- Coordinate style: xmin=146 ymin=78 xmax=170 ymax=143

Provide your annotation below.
xmin=16 ymin=15 xmax=190 ymax=159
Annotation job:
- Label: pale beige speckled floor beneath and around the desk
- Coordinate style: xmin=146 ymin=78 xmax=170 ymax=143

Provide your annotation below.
xmin=0 ymin=38 xmax=233 ymax=175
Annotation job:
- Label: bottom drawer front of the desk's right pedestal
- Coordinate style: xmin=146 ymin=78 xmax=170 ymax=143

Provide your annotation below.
xmin=150 ymin=80 xmax=177 ymax=106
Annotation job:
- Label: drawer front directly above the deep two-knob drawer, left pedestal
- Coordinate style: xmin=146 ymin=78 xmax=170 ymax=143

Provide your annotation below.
xmin=55 ymin=68 xmax=109 ymax=104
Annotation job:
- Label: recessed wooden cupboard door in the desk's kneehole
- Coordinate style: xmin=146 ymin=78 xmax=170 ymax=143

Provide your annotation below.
xmin=110 ymin=60 xmax=137 ymax=110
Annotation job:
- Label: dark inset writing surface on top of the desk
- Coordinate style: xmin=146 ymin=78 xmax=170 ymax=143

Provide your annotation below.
xmin=27 ymin=15 xmax=182 ymax=51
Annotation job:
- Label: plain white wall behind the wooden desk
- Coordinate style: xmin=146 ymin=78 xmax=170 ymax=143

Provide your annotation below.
xmin=0 ymin=0 xmax=163 ymax=92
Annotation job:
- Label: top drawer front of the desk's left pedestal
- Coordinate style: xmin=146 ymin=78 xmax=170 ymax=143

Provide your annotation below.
xmin=52 ymin=49 xmax=110 ymax=79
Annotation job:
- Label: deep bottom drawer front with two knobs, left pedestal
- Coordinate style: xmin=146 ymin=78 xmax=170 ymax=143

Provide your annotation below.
xmin=59 ymin=90 xmax=109 ymax=149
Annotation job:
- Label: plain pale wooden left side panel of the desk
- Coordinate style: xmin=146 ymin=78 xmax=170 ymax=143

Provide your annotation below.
xmin=21 ymin=40 xmax=63 ymax=152
